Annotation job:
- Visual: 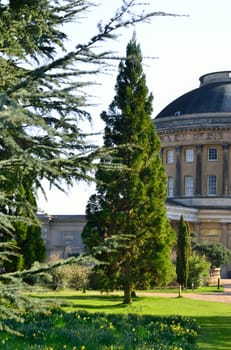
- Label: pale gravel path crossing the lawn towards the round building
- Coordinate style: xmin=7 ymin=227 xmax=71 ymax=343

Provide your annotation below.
xmin=139 ymin=279 xmax=231 ymax=304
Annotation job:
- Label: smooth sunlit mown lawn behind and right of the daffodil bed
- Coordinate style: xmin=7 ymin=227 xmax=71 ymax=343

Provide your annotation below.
xmin=33 ymin=291 xmax=231 ymax=350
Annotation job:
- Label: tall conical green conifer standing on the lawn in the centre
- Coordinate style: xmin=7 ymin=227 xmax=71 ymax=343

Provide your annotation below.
xmin=82 ymin=36 xmax=174 ymax=303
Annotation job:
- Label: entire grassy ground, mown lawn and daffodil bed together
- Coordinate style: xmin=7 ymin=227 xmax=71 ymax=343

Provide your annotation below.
xmin=0 ymin=290 xmax=231 ymax=350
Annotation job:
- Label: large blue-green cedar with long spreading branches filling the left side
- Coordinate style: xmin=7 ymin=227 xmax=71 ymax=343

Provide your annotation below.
xmin=0 ymin=0 xmax=177 ymax=329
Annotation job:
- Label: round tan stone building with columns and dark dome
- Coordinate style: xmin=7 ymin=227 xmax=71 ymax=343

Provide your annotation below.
xmin=154 ymin=71 xmax=231 ymax=277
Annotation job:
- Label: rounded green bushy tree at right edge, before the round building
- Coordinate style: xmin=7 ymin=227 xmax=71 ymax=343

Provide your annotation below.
xmin=193 ymin=241 xmax=231 ymax=268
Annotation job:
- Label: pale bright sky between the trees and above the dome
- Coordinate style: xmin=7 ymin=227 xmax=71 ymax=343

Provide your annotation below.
xmin=38 ymin=0 xmax=231 ymax=215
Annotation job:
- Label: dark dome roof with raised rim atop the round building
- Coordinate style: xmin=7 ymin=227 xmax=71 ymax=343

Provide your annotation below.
xmin=156 ymin=71 xmax=231 ymax=118
